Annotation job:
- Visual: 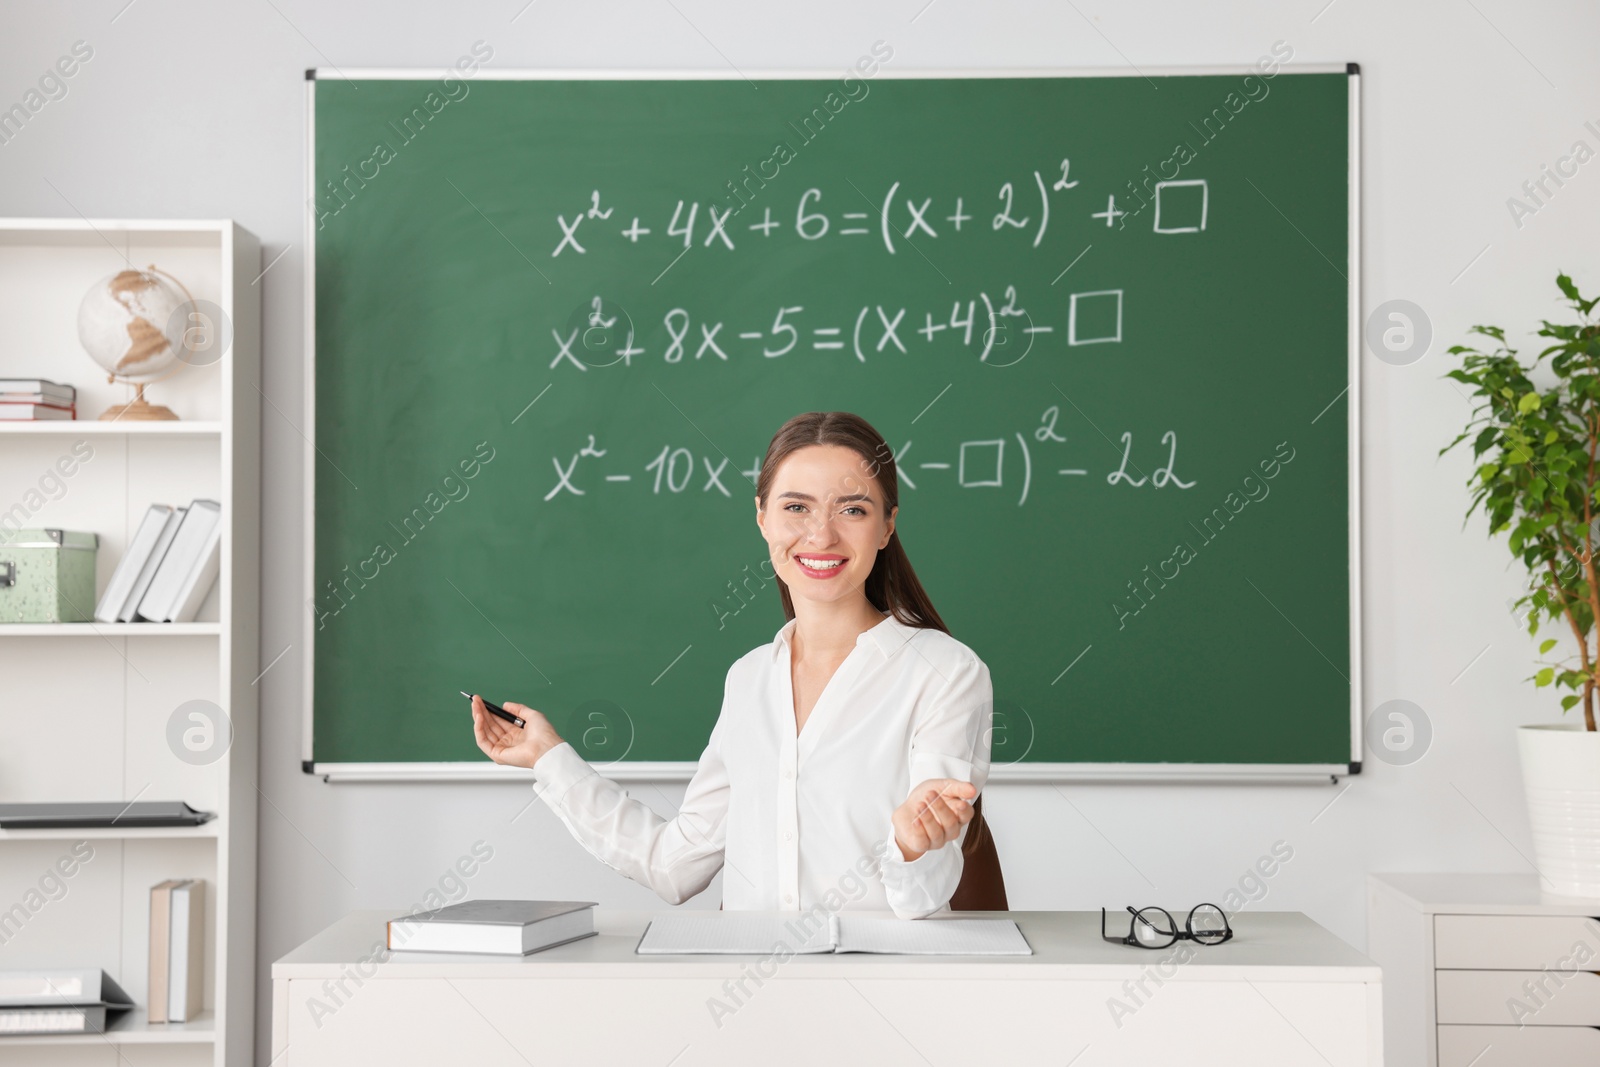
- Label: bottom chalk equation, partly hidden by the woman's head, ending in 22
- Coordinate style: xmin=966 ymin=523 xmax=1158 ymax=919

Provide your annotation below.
xmin=544 ymin=405 xmax=1197 ymax=507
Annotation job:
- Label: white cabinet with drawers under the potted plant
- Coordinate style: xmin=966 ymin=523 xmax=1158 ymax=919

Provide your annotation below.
xmin=1366 ymin=873 xmax=1600 ymax=1067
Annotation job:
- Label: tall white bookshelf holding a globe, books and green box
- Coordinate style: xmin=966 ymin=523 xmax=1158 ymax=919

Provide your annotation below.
xmin=0 ymin=218 xmax=261 ymax=1067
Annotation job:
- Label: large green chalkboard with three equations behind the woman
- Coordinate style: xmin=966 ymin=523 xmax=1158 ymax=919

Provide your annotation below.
xmin=307 ymin=64 xmax=1358 ymax=773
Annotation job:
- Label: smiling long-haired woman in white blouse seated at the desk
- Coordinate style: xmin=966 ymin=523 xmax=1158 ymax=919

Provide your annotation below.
xmin=472 ymin=411 xmax=1006 ymax=918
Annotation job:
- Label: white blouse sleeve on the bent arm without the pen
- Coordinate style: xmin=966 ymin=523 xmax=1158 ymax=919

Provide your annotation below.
xmin=882 ymin=656 xmax=994 ymax=918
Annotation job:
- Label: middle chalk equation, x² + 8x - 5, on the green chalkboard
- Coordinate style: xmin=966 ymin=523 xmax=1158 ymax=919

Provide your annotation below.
xmin=550 ymin=285 xmax=1123 ymax=371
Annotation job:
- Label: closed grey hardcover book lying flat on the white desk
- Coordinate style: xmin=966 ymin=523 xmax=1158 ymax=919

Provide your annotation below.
xmin=389 ymin=901 xmax=595 ymax=955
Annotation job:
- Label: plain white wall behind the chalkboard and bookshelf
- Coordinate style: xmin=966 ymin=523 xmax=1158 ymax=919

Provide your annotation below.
xmin=0 ymin=0 xmax=1600 ymax=1062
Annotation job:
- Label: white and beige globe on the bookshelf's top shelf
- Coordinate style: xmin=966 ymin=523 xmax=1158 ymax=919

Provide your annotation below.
xmin=78 ymin=267 xmax=190 ymax=419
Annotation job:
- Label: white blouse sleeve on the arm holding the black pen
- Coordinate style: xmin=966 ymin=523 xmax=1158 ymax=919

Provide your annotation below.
xmin=533 ymin=693 xmax=728 ymax=904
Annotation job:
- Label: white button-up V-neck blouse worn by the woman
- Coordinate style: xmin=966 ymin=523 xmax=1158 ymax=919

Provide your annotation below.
xmin=533 ymin=616 xmax=994 ymax=918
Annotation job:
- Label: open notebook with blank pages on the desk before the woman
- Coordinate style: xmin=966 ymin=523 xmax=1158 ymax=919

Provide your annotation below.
xmin=634 ymin=912 xmax=1034 ymax=957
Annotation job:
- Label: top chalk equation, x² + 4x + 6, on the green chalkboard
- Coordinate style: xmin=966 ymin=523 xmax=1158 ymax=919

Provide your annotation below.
xmin=550 ymin=175 xmax=1211 ymax=259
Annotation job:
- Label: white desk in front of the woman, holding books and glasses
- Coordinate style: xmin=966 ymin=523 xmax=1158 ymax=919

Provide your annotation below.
xmin=272 ymin=909 xmax=1382 ymax=1067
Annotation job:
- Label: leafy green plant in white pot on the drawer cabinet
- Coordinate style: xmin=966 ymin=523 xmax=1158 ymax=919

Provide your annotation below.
xmin=1440 ymin=274 xmax=1600 ymax=897
